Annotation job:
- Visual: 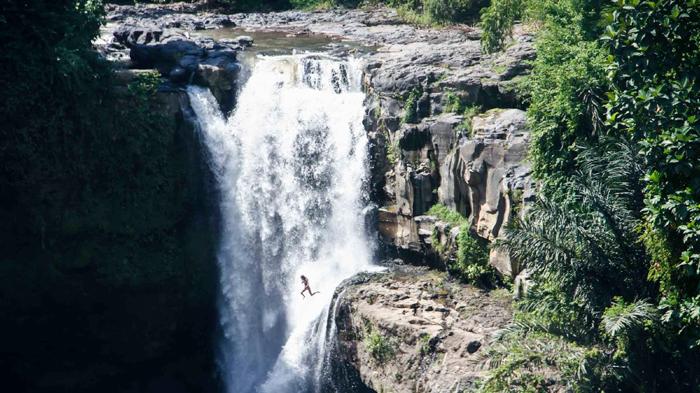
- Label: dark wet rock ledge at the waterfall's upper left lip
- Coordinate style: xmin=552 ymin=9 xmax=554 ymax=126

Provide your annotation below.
xmin=96 ymin=5 xmax=243 ymax=112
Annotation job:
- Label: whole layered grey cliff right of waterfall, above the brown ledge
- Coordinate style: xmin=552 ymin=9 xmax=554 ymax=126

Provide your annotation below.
xmin=356 ymin=19 xmax=534 ymax=277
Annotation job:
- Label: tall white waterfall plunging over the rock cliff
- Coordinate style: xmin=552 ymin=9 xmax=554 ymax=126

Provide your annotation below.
xmin=188 ymin=55 xmax=371 ymax=393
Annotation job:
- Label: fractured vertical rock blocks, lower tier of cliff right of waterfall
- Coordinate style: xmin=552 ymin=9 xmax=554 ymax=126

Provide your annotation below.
xmin=379 ymin=109 xmax=534 ymax=277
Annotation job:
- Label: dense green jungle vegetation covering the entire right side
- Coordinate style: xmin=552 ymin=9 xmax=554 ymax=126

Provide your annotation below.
xmin=481 ymin=0 xmax=700 ymax=392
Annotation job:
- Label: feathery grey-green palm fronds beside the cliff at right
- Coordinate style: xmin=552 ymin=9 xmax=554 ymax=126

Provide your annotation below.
xmin=499 ymin=144 xmax=648 ymax=314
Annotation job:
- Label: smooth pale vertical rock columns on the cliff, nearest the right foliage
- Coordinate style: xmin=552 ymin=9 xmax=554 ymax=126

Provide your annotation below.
xmin=438 ymin=109 xmax=534 ymax=277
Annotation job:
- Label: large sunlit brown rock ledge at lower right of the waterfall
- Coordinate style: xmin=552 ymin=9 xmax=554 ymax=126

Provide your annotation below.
xmin=335 ymin=267 xmax=511 ymax=393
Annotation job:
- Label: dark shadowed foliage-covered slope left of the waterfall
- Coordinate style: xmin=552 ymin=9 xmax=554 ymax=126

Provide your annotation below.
xmin=0 ymin=0 xmax=216 ymax=391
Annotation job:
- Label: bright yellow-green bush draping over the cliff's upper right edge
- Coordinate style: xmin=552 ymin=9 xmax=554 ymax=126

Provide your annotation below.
xmin=481 ymin=0 xmax=606 ymax=180
